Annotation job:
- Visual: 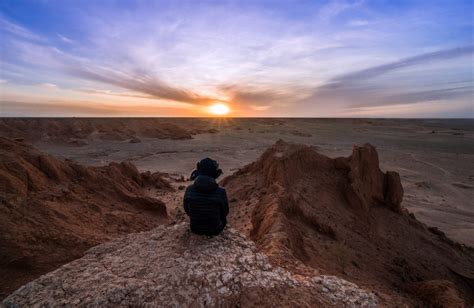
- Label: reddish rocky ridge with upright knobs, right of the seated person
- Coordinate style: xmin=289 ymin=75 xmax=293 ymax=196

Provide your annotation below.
xmin=222 ymin=141 xmax=474 ymax=306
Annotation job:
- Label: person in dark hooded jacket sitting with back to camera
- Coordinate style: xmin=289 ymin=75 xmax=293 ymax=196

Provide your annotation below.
xmin=183 ymin=158 xmax=229 ymax=236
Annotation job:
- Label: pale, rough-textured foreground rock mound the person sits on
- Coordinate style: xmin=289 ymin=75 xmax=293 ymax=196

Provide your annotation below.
xmin=2 ymin=223 xmax=377 ymax=307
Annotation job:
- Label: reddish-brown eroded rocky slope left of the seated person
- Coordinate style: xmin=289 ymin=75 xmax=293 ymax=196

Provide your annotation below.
xmin=0 ymin=137 xmax=172 ymax=298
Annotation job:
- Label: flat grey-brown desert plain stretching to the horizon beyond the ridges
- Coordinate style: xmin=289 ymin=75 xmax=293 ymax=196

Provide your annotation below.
xmin=35 ymin=118 xmax=474 ymax=246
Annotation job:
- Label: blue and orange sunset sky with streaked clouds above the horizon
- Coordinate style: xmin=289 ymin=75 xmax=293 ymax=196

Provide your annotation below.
xmin=0 ymin=0 xmax=474 ymax=118
